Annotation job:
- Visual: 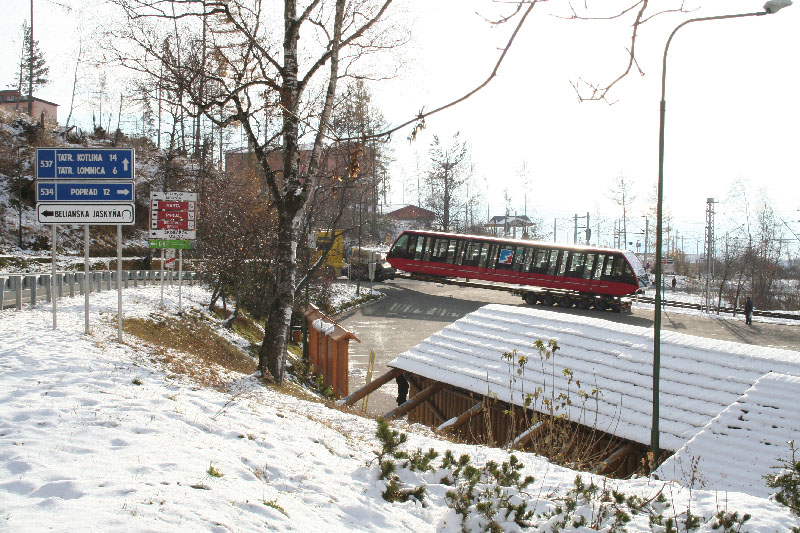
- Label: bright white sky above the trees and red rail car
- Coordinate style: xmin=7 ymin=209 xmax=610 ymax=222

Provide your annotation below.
xmin=0 ymin=0 xmax=800 ymax=253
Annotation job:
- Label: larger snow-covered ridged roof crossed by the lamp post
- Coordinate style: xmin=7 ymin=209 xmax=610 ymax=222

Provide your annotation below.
xmin=389 ymin=304 xmax=800 ymax=451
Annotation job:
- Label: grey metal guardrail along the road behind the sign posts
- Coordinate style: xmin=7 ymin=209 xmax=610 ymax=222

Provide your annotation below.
xmin=0 ymin=270 xmax=198 ymax=310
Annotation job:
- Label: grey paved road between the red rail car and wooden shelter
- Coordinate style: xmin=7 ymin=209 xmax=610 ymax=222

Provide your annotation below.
xmin=337 ymin=279 xmax=800 ymax=415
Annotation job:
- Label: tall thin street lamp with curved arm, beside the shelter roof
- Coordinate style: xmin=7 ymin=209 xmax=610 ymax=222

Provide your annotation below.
xmin=650 ymin=0 xmax=792 ymax=468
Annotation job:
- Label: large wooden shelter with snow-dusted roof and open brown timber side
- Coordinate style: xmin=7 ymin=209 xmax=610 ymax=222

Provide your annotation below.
xmin=342 ymin=304 xmax=800 ymax=476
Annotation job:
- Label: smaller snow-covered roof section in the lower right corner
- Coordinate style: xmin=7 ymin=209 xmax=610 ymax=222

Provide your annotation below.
xmin=655 ymin=373 xmax=800 ymax=498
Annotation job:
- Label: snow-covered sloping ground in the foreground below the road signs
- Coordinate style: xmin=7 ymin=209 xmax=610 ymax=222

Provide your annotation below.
xmin=0 ymin=287 xmax=798 ymax=532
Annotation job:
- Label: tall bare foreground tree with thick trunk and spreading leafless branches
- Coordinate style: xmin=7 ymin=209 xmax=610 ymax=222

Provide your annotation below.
xmin=103 ymin=0 xmax=684 ymax=383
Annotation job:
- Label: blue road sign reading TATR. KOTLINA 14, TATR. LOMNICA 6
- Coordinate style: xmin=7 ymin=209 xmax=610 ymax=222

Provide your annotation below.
xmin=36 ymin=148 xmax=134 ymax=180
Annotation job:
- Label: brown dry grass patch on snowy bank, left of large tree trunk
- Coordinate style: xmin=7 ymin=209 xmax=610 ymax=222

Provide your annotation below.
xmin=123 ymin=311 xmax=257 ymax=389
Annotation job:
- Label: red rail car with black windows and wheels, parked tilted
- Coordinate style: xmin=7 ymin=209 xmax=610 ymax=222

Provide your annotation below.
xmin=386 ymin=230 xmax=649 ymax=311
